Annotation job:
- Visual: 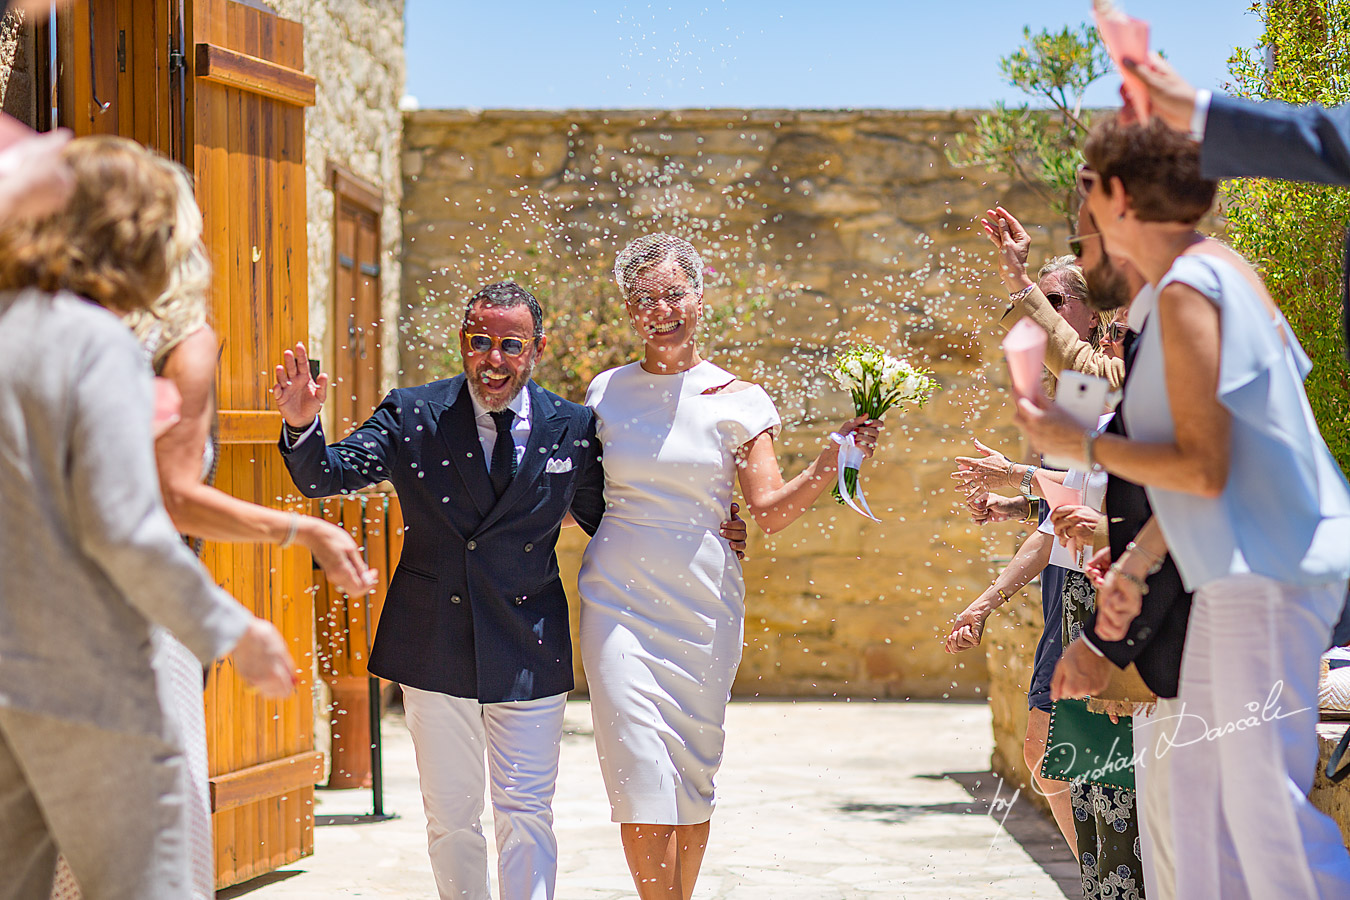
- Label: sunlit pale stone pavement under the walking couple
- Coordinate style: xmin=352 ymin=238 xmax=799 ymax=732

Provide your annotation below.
xmin=219 ymin=700 xmax=1080 ymax=900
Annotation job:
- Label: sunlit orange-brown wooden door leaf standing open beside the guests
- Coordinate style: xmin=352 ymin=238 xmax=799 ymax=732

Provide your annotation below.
xmin=186 ymin=0 xmax=323 ymax=887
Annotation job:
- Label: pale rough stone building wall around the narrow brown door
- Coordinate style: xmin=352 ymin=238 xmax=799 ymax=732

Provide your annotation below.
xmin=263 ymin=0 xmax=405 ymax=389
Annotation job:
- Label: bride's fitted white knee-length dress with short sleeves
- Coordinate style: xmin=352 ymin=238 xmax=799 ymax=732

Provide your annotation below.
xmin=579 ymin=362 xmax=779 ymax=824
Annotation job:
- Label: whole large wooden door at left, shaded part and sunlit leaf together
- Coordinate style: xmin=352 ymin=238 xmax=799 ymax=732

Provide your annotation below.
xmin=55 ymin=0 xmax=323 ymax=887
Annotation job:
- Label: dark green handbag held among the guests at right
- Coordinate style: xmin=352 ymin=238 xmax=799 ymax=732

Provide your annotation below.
xmin=1041 ymin=700 xmax=1134 ymax=791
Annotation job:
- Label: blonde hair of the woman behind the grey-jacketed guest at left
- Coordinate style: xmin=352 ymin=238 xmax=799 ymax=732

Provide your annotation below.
xmin=126 ymin=157 xmax=211 ymax=371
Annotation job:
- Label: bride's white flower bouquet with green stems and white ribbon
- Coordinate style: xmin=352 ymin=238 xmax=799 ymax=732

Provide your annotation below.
xmin=830 ymin=344 xmax=937 ymax=522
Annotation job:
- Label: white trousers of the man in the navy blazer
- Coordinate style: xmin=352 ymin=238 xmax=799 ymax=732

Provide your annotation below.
xmin=404 ymin=687 xmax=567 ymax=900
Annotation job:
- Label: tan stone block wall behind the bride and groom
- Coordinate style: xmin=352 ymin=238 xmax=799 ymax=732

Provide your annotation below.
xmin=404 ymin=109 xmax=1067 ymax=712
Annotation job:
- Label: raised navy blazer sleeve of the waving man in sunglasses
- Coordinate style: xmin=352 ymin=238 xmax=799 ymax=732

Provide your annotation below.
xmin=277 ymin=390 xmax=402 ymax=497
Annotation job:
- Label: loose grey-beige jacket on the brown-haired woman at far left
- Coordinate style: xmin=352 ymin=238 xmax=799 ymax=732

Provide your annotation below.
xmin=0 ymin=290 xmax=251 ymax=735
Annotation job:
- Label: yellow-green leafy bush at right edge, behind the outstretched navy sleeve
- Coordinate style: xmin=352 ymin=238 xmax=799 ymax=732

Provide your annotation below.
xmin=1224 ymin=0 xmax=1350 ymax=470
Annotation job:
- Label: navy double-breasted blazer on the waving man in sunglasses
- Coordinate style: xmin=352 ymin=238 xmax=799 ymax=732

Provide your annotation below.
xmin=279 ymin=375 xmax=605 ymax=703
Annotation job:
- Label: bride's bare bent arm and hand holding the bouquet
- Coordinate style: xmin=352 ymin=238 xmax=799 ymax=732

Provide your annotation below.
xmin=736 ymin=416 xmax=882 ymax=534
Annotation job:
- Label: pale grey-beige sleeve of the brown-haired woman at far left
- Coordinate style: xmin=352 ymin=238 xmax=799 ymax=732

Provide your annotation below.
xmin=69 ymin=334 xmax=252 ymax=663
